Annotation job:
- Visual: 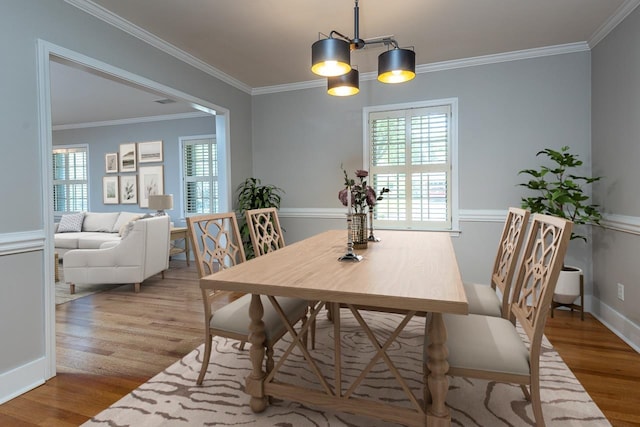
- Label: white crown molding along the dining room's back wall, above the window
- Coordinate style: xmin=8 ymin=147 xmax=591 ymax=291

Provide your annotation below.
xmin=251 ymin=42 xmax=592 ymax=95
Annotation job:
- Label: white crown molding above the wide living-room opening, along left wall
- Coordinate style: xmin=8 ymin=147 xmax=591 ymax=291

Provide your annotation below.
xmin=64 ymin=0 xmax=251 ymax=94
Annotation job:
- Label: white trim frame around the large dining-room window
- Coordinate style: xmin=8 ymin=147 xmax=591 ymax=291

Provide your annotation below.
xmin=362 ymin=98 xmax=460 ymax=235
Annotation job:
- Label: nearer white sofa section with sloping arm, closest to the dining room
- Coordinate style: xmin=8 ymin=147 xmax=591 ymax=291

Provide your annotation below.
xmin=63 ymin=216 xmax=170 ymax=293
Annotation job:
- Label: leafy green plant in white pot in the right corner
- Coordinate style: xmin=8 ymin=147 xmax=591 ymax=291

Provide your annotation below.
xmin=518 ymin=146 xmax=602 ymax=305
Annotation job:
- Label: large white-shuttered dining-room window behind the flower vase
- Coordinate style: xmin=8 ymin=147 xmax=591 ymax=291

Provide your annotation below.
xmin=365 ymin=100 xmax=457 ymax=230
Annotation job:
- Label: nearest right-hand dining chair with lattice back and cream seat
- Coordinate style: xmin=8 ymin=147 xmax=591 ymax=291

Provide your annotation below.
xmin=424 ymin=214 xmax=573 ymax=426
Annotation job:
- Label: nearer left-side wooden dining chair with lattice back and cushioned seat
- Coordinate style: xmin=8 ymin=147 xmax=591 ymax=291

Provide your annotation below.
xmin=187 ymin=212 xmax=308 ymax=385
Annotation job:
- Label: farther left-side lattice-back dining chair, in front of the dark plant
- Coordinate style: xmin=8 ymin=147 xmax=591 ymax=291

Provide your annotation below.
xmin=245 ymin=208 xmax=316 ymax=348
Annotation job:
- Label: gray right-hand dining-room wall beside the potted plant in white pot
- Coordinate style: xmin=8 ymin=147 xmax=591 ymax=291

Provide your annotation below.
xmin=591 ymin=5 xmax=640 ymax=348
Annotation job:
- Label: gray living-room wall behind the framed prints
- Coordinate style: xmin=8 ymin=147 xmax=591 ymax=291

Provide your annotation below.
xmin=53 ymin=116 xmax=216 ymax=225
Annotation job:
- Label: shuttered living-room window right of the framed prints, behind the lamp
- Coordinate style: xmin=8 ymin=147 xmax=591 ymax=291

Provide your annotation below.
xmin=180 ymin=135 xmax=220 ymax=217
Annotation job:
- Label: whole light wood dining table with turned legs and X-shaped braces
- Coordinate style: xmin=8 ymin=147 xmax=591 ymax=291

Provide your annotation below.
xmin=200 ymin=230 xmax=468 ymax=426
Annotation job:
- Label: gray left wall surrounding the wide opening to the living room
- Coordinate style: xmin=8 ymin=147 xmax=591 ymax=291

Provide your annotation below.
xmin=0 ymin=0 xmax=252 ymax=402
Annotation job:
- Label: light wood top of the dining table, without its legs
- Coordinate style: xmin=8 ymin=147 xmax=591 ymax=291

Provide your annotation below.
xmin=200 ymin=230 xmax=468 ymax=314
